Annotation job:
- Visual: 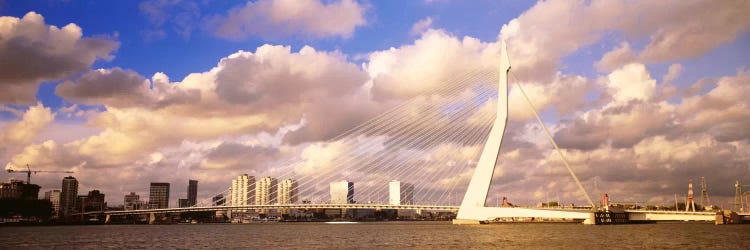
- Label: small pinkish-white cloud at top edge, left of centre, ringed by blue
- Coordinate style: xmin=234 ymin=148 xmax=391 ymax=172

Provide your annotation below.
xmin=206 ymin=0 xmax=367 ymax=40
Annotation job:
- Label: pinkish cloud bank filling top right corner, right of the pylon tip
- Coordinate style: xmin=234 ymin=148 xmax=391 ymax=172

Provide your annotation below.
xmin=500 ymin=0 xmax=750 ymax=78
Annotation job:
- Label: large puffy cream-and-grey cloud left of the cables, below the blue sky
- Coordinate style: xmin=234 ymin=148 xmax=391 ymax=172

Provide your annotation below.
xmin=4 ymin=45 xmax=377 ymax=180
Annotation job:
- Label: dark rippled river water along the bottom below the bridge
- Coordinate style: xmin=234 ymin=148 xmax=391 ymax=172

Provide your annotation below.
xmin=0 ymin=222 xmax=750 ymax=249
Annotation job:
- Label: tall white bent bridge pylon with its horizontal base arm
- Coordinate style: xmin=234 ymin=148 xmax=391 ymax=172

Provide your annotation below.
xmin=453 ymin=41 xmax=591 ymax=224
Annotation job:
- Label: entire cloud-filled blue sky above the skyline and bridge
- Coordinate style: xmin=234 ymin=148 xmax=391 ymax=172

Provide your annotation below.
xmin=0 ymin=0 xmax=750 ymax=206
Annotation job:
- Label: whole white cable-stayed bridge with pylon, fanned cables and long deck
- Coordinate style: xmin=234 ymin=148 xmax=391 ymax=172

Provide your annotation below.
xmin=84 ymin=43 xmax=732 ymax=224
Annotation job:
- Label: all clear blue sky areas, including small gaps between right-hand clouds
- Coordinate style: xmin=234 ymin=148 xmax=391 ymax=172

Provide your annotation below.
xmin=0 ymin=0 xmax=750 ymax=113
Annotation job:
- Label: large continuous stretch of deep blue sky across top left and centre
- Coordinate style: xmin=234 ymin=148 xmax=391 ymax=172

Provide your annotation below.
xmin=0 ymin=0 xmax=533 ymax=86
